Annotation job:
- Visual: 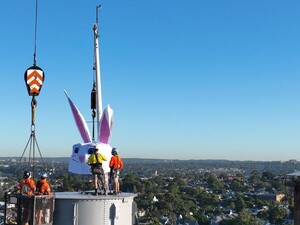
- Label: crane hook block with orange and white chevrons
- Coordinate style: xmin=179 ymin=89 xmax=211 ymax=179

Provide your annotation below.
xmin=24 ymin=66 xmax=45 ymax=96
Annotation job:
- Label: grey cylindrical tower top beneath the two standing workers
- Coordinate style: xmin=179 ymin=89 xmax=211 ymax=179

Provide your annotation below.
xmin=53 ymin=192 xmax=136 ymax=225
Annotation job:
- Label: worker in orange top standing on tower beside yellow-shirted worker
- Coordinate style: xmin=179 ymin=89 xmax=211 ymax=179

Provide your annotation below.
xmin=109 ymin=148 xmax=123 ymax=194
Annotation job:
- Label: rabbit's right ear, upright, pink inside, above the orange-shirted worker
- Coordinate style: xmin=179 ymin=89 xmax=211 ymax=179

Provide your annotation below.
xmin=98 ymin=105 xmax=113 ymax=144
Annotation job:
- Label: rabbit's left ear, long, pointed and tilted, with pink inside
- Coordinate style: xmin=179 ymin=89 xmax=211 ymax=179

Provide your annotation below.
xmin=65 ymin=91 xmax=91 ymax=143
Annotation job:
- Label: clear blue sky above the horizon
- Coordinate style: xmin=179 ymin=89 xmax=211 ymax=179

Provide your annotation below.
xmin=0 ymin=0 xmax=300 ymax=160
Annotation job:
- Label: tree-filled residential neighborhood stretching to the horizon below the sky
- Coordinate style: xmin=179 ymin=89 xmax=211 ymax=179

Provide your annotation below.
xmin=0 ymin=159 xmax=300 ymax=225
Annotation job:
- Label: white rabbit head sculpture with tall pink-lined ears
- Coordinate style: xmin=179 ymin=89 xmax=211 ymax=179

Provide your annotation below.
xmin=65 ymin=91 xmax=113 ymax=174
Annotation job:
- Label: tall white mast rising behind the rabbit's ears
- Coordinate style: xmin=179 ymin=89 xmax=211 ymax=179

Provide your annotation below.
xmin=93 ymin=5 xmax=102 ymax=131
